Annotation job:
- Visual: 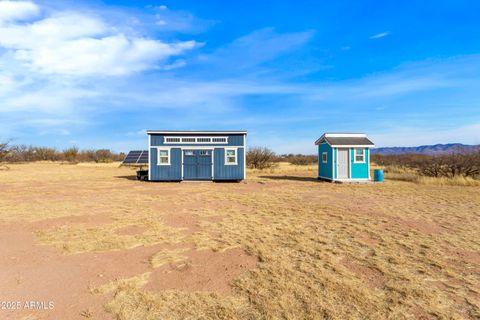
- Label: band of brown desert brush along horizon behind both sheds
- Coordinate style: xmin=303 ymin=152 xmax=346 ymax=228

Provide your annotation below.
xmin=0 ymin=142 xmax=480 ymax=178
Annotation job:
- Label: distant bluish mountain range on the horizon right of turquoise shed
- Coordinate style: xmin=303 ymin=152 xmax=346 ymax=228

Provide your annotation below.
xmin=372 ymin=143 xmax=480 ymax=155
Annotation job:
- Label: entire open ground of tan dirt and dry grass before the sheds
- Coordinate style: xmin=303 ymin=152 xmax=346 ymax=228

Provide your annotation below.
xmin=0 ymin=163 xmax=480 ymax=320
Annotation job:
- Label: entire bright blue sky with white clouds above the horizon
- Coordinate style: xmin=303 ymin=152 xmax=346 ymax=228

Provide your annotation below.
xmin=0 ymin=0 xmax=480 ymax=153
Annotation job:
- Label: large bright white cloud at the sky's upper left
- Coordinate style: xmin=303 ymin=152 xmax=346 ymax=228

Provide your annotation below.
xmin=0 ymin=3 xmax=197 ymax=76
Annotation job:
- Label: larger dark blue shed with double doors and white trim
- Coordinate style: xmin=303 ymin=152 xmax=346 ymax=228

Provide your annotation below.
xmin=147 ymin=130 xmax=247 ymax=181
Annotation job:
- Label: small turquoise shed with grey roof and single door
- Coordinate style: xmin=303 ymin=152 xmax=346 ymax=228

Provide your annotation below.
xmin=315 ymin=133 xmax=374 ymax=182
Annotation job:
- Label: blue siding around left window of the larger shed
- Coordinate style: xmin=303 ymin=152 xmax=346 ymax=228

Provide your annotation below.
xmin=149 ymin=147 xmax=182 ymax=181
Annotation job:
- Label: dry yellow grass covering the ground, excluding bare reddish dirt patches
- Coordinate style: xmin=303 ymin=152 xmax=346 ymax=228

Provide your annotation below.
xmin=0 ymin=164 xmax=480 ymax=319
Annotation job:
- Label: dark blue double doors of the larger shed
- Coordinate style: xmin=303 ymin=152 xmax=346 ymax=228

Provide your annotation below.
xmin=183 ymin=150 xmax=212 ymax=180
